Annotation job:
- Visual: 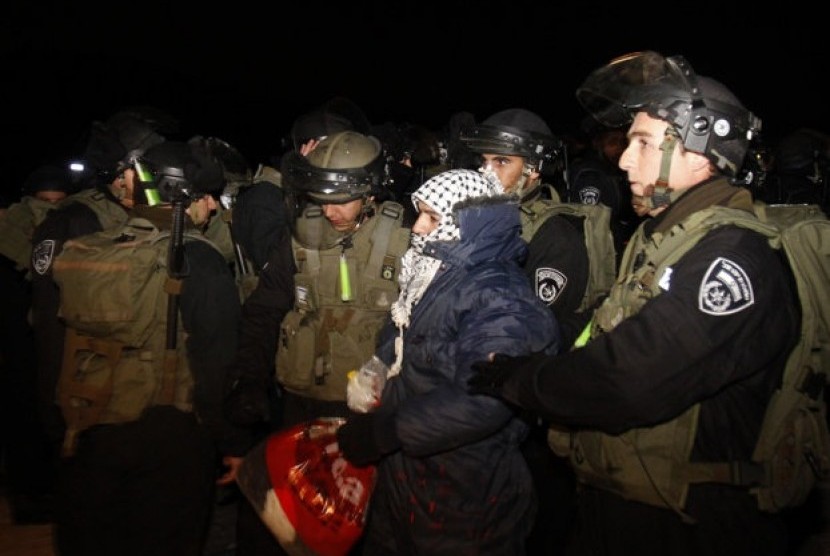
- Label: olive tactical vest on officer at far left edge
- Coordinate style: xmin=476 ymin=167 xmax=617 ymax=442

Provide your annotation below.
xmin=0 ymin=196 xmax=59 ymax=271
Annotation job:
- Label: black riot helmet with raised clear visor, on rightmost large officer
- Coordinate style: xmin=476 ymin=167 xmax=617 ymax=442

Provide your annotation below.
xmin=576 ymin=51 xmax=761 ymax=177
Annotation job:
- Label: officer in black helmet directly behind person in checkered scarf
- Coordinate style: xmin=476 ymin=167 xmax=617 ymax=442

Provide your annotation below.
xmin=459 ymin=108 xmax=604 ymax=554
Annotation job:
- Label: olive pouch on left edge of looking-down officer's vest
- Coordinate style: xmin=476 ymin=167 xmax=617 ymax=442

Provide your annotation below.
xmin=277 ymin=311 xmax=318 ymax=392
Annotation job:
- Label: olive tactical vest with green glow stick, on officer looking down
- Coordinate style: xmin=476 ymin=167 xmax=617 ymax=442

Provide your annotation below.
xmin=277 ymin=202 xmax=409 ymax=401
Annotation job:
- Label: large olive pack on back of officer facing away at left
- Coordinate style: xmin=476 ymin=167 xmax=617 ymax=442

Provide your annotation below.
xmin=53 ymin=218 xmax=216 ymax=455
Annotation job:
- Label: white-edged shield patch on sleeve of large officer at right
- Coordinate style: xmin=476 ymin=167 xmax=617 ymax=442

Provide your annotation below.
xmin=698 ymin=257 xmax=755 ymax=316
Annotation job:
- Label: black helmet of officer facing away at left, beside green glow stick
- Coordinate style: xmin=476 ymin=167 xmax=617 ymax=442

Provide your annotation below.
xmin=133 ymin=141 xmax=225 ymax=206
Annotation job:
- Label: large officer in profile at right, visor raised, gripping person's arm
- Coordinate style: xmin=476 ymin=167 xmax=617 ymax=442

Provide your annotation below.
xmin=471 ymin=51 xmax=800 ymax=556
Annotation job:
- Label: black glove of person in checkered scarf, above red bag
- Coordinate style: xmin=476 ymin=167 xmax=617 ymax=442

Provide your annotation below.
xmin=337 ymin=412 xmax=400 ymax=467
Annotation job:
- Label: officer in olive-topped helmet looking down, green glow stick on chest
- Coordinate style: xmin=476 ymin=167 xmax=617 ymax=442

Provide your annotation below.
xmin=226 ymin=131 xmax=409 ymax=555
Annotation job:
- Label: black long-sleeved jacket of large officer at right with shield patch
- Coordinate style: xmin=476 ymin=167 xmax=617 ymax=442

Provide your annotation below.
xmin=490 ymin=182 xmax=800 ymax=554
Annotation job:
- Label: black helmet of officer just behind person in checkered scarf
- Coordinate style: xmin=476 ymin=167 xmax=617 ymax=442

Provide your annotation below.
xmin=459 ymin=108 xmax=562 ymax=171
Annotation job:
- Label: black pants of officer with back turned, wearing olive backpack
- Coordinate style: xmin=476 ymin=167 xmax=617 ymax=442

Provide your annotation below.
xmin=54 ymin=406 xmax=216 ymax=556
